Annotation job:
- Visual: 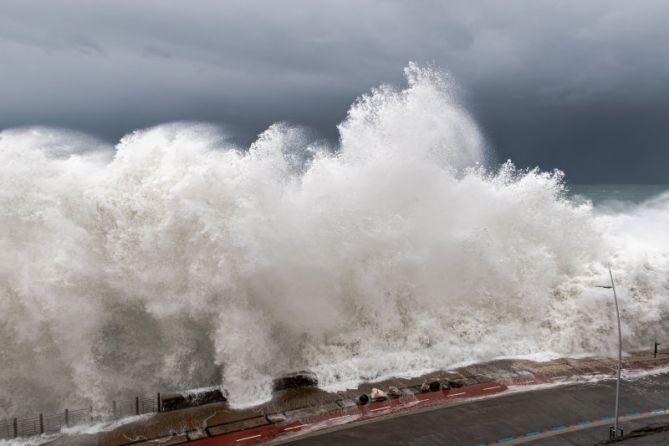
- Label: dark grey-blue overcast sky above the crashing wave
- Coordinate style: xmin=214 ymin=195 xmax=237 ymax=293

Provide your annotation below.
xmin=0 ymin=0 xmax=669 ymax=183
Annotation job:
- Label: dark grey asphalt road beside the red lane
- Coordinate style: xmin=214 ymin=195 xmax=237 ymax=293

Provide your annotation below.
xmin=278 ymin=374 xmax=669 ymax=446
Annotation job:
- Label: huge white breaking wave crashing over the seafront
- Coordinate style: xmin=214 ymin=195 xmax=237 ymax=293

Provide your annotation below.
xmin=0 ymin=65 xmax=669 ymax=416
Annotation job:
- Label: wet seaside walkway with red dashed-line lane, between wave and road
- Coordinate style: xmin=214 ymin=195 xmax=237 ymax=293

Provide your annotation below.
xmin=40 ymin=351 xmax=669 ymax=446
